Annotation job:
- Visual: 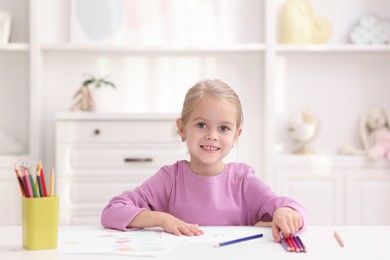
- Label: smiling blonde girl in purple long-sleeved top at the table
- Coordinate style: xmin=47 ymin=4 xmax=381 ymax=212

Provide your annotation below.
xmin=101 ymin=80 xmax=306 ymax=242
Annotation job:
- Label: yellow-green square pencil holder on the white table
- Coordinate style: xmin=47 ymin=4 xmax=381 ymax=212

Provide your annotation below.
xmin=22 ymin=196 xmax=59 ymax=250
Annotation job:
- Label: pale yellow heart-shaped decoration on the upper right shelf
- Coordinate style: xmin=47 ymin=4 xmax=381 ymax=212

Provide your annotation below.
xmin=281 ymin=0 xmax=333 ymax=44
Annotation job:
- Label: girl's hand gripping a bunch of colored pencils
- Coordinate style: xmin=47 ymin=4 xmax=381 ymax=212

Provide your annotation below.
xmin=272 ymin=207 xmax=303 ymax=242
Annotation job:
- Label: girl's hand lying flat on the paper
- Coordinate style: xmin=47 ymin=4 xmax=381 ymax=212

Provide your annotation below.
xmin=161 ymin=214 xmax=203 ymax=236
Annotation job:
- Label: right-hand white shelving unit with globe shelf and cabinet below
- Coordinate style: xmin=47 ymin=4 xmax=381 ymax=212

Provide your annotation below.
xmin=265 ymin=0 xmax=390 ymax=225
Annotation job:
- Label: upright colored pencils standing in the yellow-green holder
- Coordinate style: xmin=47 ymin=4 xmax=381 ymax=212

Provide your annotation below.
xmin=14 ymin=160 xmax=55 ymax=198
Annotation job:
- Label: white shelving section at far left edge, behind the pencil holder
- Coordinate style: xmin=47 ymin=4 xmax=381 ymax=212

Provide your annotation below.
xmin=0 ymin=0 xmax=41 ymax=224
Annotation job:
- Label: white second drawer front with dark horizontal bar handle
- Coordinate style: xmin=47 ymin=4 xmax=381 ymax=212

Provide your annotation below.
xmin=69 ymin=147 xmax=186 ymax=174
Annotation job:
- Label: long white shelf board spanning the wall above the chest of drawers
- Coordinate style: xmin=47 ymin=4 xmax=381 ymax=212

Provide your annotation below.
xmin=42 ymin=43 xmax=265 ymax=53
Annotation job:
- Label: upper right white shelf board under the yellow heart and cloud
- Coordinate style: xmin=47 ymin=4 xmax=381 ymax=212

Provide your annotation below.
xmin=276 ymin=44 xmax=390 ymax=53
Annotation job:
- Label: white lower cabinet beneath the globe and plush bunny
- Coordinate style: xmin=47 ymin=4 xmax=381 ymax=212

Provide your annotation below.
xmin=273 ymin=156 xmax=390 ymax=226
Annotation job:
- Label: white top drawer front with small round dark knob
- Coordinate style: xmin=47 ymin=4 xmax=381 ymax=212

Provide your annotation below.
xmin=56 ymin=120 xmax=180 ymax=143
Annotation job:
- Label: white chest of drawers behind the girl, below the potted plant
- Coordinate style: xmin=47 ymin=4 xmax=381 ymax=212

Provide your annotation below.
xmin=56 ymin=113 xmax=187 ymax=225
